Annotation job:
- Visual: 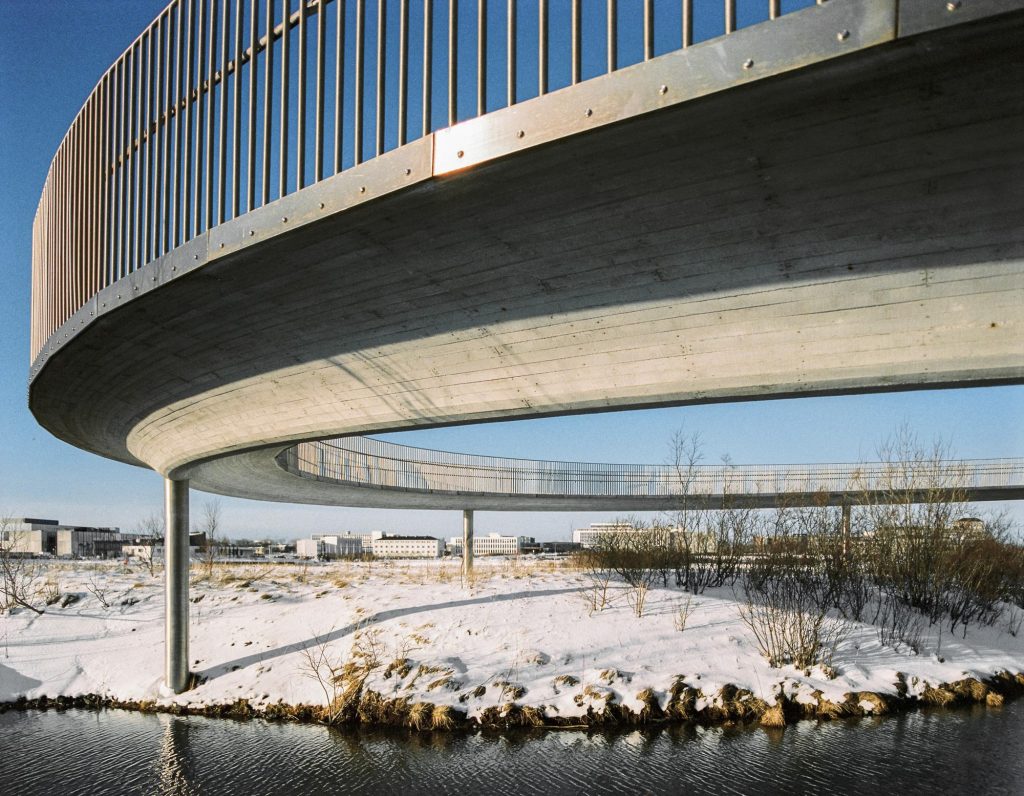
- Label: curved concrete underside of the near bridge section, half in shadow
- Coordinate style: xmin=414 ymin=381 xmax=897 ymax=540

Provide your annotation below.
xmin=30 ymin=13 xmax=1024 ymax=489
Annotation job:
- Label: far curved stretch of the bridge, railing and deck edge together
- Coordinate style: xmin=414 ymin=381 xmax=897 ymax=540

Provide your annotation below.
xmin=268 ymin=436 xmax=1024 ymax=511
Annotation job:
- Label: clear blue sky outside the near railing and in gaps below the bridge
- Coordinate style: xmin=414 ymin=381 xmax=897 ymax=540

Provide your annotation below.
xmin=0 ymin=0 xmax=1024 ymax=539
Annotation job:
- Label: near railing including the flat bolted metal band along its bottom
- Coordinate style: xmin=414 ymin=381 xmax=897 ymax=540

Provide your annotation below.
xmin=31 ymin=0 xmax=1014 ymax=366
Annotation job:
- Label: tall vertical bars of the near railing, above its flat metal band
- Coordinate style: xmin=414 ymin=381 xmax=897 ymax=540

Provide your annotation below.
xmin=31 ymin=0 xmax=823 ymax=360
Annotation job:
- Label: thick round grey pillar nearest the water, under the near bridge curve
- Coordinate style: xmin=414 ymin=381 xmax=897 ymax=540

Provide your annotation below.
xmin=164 ymin=478 xmax=188 ymax=694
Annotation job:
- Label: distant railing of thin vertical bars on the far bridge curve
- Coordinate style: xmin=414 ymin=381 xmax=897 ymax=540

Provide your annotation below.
xmin=286 ymin=436 xmax=1024 ymax=498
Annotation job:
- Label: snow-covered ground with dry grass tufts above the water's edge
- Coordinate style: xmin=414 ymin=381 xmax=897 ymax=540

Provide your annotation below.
xmin=0 ymin=558 xmax=1024 ymax=718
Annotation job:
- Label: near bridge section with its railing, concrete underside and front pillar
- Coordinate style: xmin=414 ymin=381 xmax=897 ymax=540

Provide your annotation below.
xmin=29 ymin=0 xmax=1024 ymax=689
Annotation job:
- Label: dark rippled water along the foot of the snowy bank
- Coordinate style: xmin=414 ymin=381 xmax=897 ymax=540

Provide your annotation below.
xmin=6 ymin=703 xmax=1024 ymax=796
